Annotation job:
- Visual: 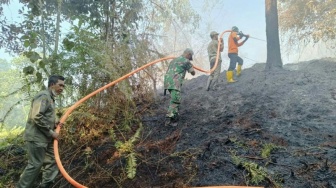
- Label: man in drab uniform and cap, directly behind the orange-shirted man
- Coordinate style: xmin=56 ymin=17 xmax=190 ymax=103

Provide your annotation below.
xmin=206 ymin=31 xmax=224 ymax=91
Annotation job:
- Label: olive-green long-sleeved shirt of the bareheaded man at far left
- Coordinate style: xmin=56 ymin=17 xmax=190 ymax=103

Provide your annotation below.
xmin=24 ymin=90 xmax=56 ymax=143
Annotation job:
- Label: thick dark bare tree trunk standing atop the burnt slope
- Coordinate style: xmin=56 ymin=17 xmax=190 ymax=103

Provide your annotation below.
xmin=265 ymin=0 xmax=282 ymax=70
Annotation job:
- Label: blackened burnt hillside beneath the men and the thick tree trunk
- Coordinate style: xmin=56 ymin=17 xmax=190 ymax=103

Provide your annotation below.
xmin=137 ymin=59 xmax=336 ymax=188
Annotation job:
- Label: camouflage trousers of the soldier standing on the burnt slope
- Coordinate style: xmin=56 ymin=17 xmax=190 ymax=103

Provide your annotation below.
xmin=166 ymin=89 xmax=181 ymax=119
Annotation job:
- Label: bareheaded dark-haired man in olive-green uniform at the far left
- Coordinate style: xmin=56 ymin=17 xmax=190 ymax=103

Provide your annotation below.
xmin=16 ymin=75 xmax=65 ymax=188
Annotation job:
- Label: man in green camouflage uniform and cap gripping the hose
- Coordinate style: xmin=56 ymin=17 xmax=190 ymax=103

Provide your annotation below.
xmin=164 ymin=48 xmax=195 ymax=126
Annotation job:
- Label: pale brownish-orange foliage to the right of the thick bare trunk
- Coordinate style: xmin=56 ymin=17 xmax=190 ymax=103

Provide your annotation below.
xmin=279 ymin=0 xmax=336 ymax=51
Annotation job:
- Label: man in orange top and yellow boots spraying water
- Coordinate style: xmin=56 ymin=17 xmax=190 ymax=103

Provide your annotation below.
xmin=226 ymin=26 xmax=250 ymax=83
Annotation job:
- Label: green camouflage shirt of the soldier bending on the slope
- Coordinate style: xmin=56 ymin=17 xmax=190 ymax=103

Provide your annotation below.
xmin=164 ymin=56 xmax=194 ymax=91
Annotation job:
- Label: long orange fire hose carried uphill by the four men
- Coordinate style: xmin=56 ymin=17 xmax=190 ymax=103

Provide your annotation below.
xmin=54 ymin=30 xmax=262 ymax=188
